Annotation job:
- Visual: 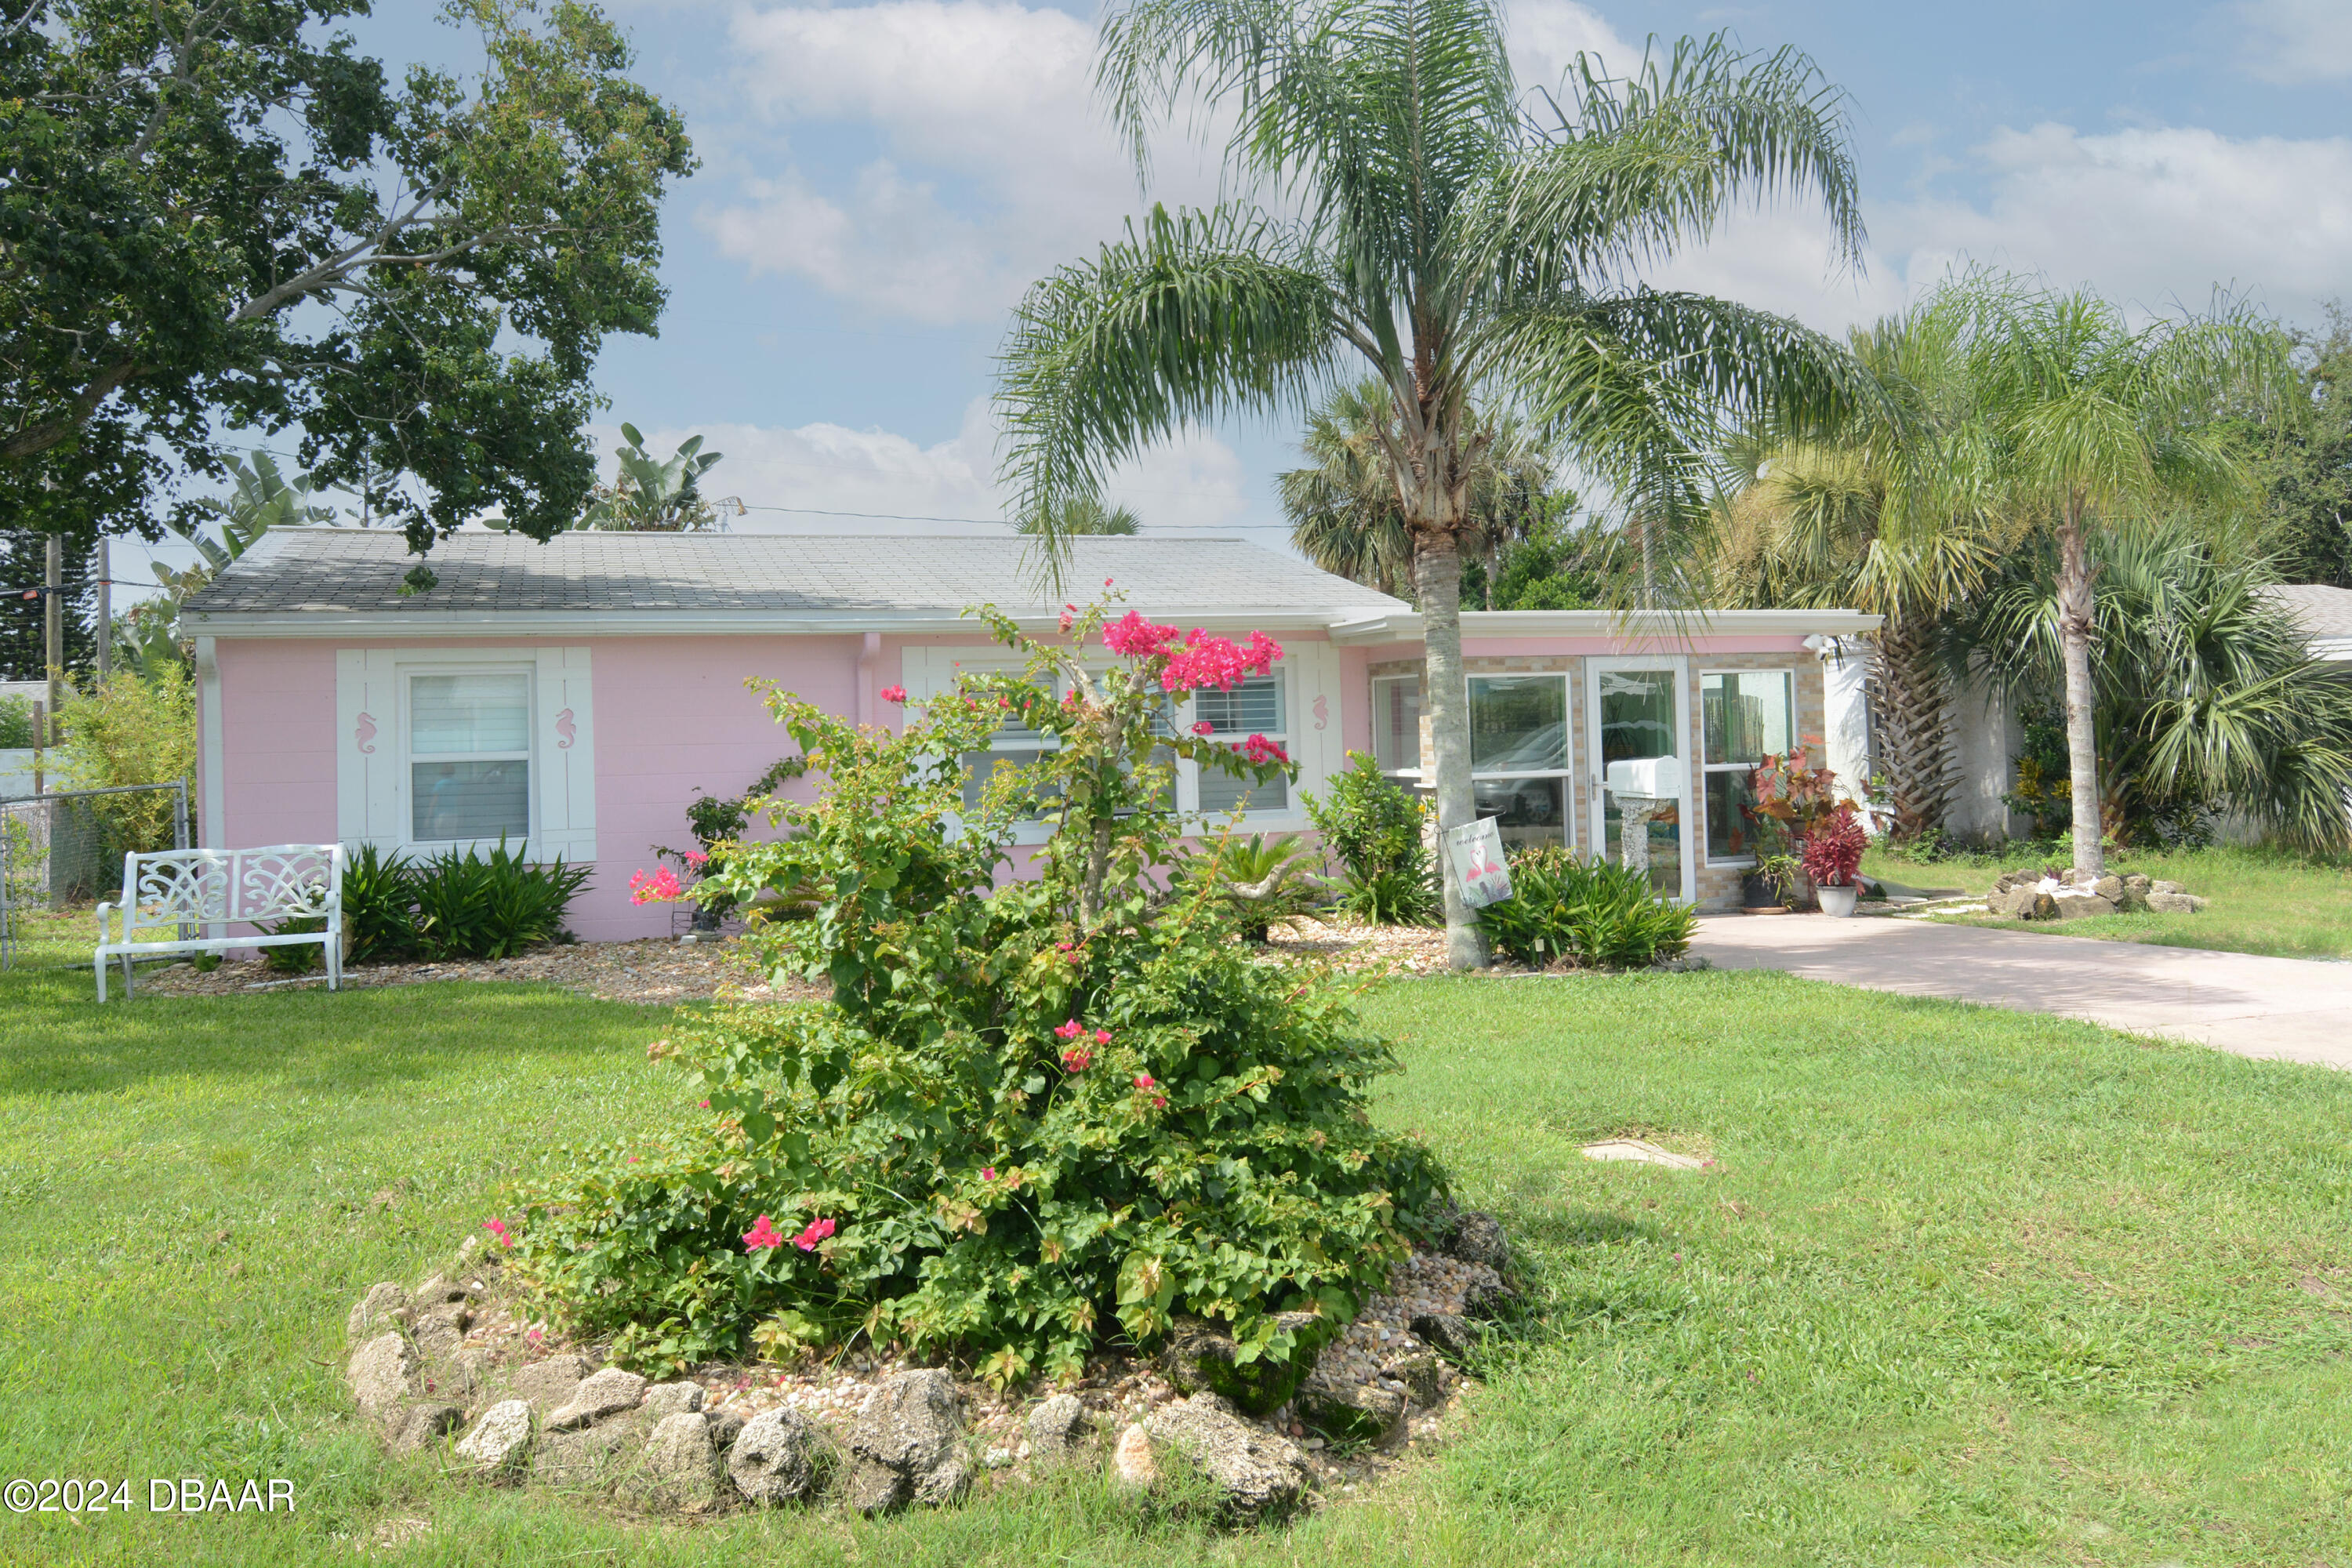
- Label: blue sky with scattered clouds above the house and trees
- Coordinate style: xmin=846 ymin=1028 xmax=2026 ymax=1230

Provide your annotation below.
xmin=151 ymin=0 xmax=2352 ymax=573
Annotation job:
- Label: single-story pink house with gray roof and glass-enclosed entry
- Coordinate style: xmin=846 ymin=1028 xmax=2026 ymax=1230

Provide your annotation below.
xmin=181 ymin=529 xmax=1877 ymax=940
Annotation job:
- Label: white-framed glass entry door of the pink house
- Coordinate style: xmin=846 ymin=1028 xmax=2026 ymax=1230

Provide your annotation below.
xmin=1585 ymin=656 xmax=1698 ymax=902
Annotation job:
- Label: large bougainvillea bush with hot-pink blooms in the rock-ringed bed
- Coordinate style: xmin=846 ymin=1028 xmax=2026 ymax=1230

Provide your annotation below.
xmin=513 ymin=592 xmax=1442 ymax=1382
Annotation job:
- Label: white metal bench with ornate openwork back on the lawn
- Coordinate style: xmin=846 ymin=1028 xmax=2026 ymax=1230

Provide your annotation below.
xmin=92 ymin=844 xmax=343 ymax=1001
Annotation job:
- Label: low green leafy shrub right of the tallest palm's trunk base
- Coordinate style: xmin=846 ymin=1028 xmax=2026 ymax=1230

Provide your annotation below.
xmin=1479 ymin=846 xmax=1698 ymax=968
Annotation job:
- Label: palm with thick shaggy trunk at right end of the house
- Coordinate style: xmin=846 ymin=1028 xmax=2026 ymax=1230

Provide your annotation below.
xmin=1710 ymin=308 xmax=2020 ymax=834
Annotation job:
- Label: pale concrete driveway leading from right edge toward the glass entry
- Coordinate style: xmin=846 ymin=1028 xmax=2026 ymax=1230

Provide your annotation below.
xmin=1691 ymin=914 xmax=2352 ymax=1067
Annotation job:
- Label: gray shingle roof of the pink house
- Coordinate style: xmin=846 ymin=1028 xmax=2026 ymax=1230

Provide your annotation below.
xmin=186 ymin=529 xmax=1404 ymax=621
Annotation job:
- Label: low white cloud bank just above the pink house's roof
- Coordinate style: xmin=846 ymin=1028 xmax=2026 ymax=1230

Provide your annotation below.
xmin=593 ymin=397 xmax=1251 ymax=534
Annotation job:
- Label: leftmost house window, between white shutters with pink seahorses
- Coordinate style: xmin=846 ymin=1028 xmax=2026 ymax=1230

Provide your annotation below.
xmin=407 ymin=670 xmax=532 ymax=846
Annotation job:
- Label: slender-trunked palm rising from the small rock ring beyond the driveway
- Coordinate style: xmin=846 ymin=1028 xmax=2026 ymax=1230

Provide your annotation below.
xmin=1936 ymin=273 xmax=2293 ymax=874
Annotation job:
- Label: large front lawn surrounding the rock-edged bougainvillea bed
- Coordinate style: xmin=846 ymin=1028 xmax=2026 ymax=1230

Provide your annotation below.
xmin=0 ymin=973 xmax=2352 ymax=1568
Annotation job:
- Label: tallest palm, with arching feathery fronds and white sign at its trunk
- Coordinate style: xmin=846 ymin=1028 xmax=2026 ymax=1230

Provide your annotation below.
xmin=1000 ymin=0 xmax=1860 ymax=966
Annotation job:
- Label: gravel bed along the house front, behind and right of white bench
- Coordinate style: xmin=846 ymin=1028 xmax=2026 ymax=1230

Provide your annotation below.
xmin=139 ymin=935 xmax=826 ymax=1004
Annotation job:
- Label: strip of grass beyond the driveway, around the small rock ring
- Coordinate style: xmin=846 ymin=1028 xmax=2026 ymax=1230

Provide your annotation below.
xmin=1863 ymin=848 xmax=2352 ymax=959
